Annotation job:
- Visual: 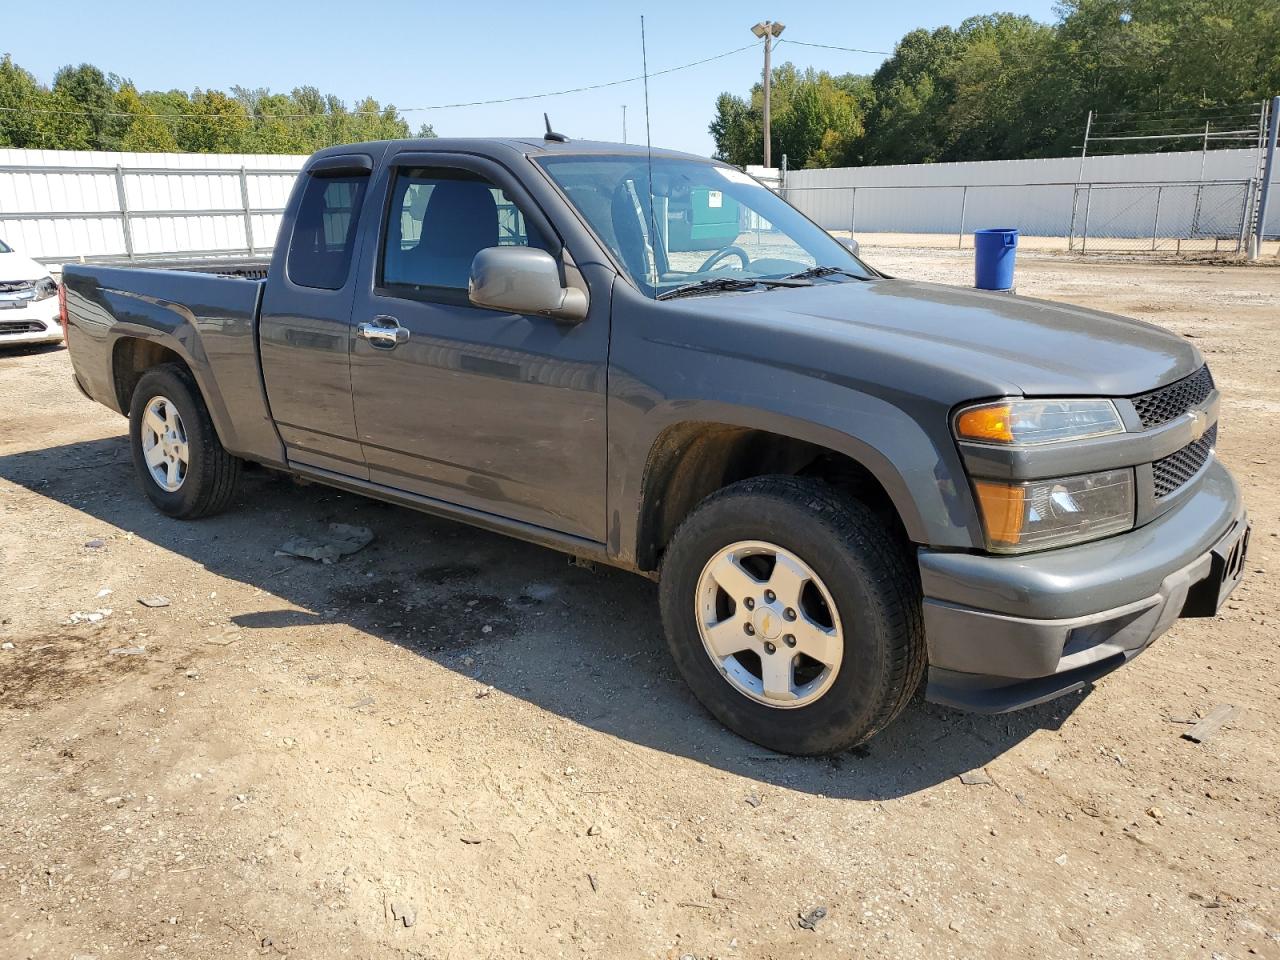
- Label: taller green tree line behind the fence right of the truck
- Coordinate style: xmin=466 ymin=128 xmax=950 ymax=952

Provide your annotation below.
xmin=710 ymin=0 xmax=1280 ymax=168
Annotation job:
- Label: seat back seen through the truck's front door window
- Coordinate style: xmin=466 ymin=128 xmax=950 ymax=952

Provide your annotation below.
xmin=404 ymin=180 xmax=498 ymax=289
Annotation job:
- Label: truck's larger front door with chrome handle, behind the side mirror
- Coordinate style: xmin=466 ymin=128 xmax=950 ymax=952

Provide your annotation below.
xmin=351 ymin=152 xmax=609 ymax=541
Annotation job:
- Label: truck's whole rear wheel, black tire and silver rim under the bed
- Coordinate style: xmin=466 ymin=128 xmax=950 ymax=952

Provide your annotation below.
xmin=129 ymin=364 xmax=241 ymax=520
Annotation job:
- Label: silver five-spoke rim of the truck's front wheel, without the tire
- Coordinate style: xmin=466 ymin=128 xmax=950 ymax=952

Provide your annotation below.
xmin=695 ymin=540 xmax=845 ymax=709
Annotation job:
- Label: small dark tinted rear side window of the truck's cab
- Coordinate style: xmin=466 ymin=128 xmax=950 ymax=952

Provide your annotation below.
xmin=285 ymin=174 xmax=369 ymax=291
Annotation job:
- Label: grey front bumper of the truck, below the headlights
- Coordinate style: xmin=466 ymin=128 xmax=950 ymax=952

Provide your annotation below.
xmin=919 ymin=460 xmax=1249 ymax=713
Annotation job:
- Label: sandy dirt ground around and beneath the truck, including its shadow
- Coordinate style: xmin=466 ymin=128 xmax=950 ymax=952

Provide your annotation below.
xmin=0 ymin=243 xmax=1280 ymax=960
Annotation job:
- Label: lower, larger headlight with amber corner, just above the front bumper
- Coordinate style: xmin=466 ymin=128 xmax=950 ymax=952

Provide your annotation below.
xmin=973 ymin=470 xmax=1134 ymax=553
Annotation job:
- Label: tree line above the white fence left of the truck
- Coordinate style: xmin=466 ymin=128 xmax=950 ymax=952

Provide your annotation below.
xmin=0 ymin=54 xmax=435 ymax=154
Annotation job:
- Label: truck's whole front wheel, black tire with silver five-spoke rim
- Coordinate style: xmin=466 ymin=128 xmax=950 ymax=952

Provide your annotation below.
xmin=659 ymin=476 xmax=927 ymax=755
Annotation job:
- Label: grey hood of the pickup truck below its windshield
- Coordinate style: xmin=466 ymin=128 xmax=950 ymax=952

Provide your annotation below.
xmin=686 ymin=279 xmax=1203 ymax=402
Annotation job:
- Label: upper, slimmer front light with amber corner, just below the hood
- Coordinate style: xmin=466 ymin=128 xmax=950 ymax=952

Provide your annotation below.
xmin=955 ymin=399 xmax=1124 ymax=447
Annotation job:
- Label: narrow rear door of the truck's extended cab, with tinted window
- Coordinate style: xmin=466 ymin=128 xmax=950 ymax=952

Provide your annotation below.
xmin=259 ymin=154 xmax=372 ymax=479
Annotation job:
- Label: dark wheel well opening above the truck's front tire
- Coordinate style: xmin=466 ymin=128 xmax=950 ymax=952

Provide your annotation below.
xmin=636 ymin=421 xmax=909 ymax=571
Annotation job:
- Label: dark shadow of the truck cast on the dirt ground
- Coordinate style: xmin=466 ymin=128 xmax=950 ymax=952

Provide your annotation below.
xmin=0 ymin=436 xmax=1084 ymax=800
